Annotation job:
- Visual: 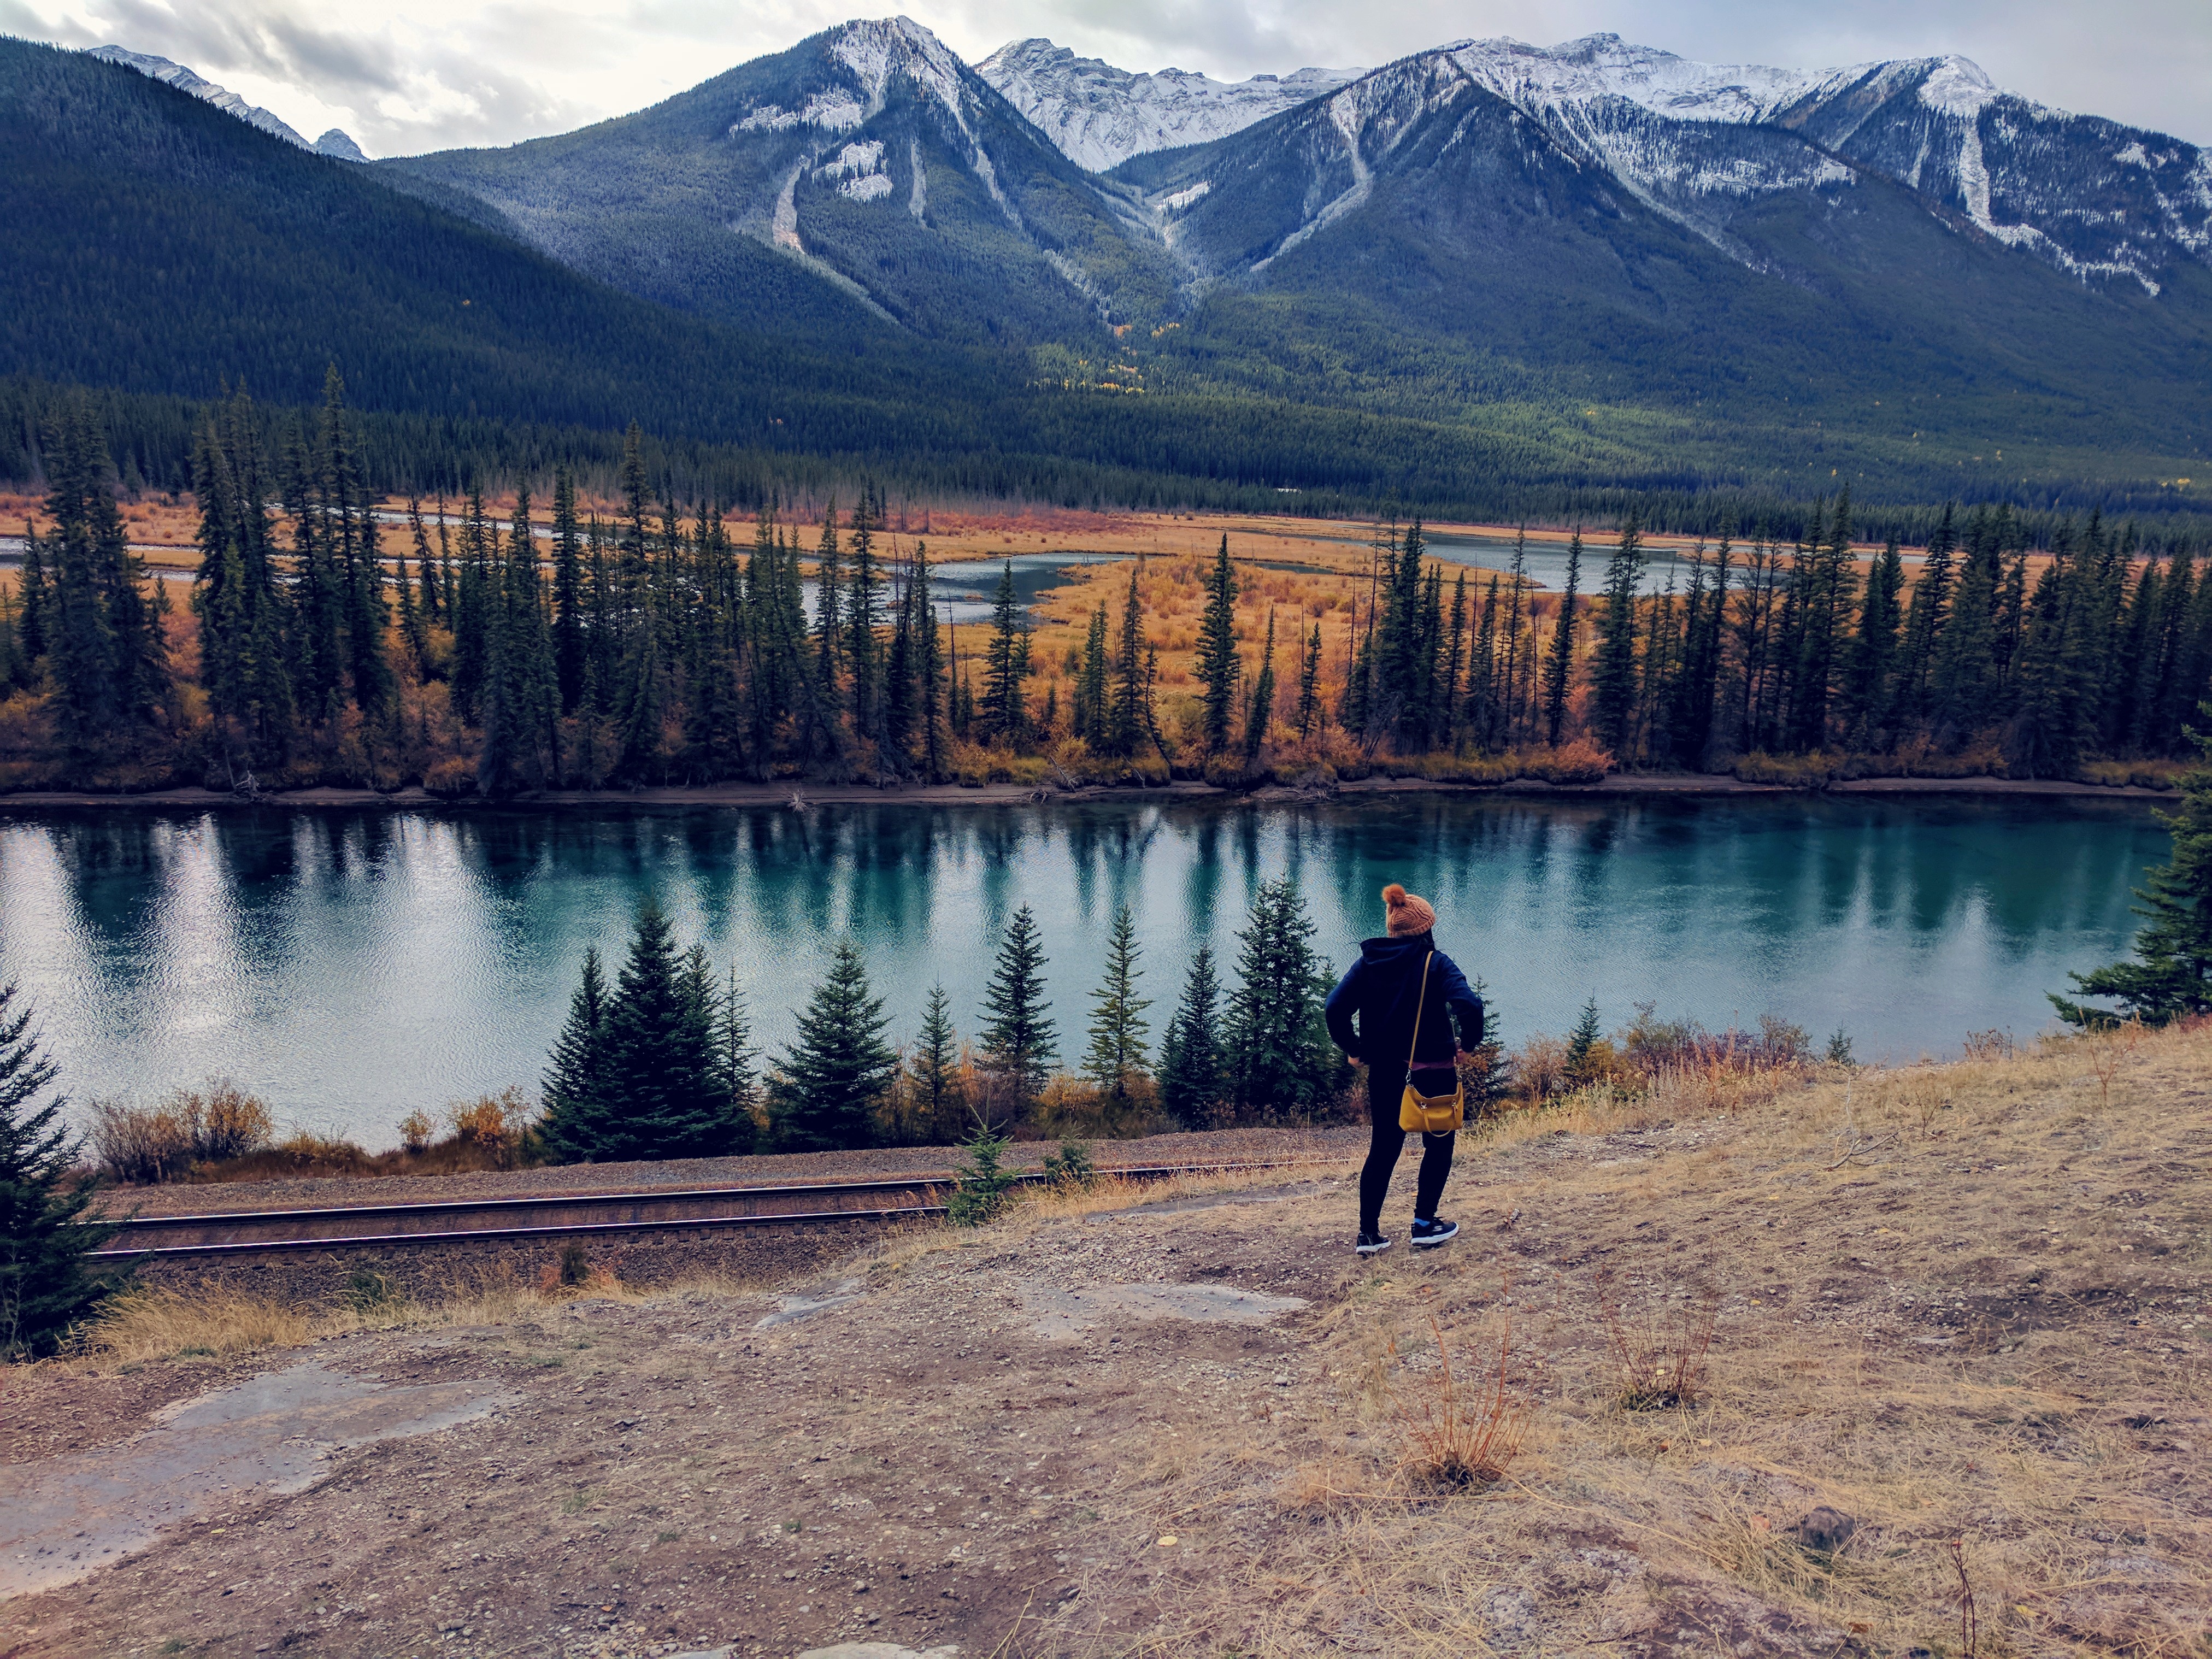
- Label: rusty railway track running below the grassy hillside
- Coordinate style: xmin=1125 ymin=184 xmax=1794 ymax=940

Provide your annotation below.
xmin=93 ymin=1159 xmax=1338 ymax=1261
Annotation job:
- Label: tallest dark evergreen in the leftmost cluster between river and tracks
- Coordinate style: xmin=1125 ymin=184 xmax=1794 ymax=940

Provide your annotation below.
xmin=593 ymin=903 xmax=745 ymax=1161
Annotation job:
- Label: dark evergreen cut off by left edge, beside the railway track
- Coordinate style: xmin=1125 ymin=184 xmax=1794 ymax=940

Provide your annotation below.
xmin=0 ymin=984 xmax=115 ymax=1361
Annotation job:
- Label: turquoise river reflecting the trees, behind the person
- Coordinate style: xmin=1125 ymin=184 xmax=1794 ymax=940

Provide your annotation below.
xmin=0 ymin=796 xmax=2166 ymax=1144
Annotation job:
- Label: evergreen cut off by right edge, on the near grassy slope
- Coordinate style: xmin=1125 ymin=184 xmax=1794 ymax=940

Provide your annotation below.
xmin=2050 ymin=725 xmax=2212 ymax=1031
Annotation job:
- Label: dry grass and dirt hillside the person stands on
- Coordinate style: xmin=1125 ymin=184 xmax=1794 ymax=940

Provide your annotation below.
xmin=0 ymin=1031 xmax=2212 ymax=1659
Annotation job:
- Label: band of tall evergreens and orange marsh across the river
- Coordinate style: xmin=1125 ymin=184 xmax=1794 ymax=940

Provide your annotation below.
xmin=0 ymin=385 xmax=2212 ymax=803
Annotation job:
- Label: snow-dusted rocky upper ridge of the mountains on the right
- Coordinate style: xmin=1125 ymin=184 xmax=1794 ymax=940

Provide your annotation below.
xmin=1141 ymin=33 xmax=2212 ymax=296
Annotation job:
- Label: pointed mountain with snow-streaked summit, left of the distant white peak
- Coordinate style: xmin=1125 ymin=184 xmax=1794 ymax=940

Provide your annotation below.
xmin=393 ymin=17 xmax=1177 ymax=345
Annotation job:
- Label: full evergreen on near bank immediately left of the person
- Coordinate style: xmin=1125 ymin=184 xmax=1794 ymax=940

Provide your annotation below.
xmin=1223 ymin=876 xmax=1343 ymax=1117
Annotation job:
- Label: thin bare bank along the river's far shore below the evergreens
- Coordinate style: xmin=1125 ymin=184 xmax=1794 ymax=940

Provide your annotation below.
xmin=0 ymin=772 xmax=2174 ymax=814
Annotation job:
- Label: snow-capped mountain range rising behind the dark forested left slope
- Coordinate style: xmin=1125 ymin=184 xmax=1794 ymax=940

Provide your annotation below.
xmin=0 ymin=17 xmax=2212 ymax=513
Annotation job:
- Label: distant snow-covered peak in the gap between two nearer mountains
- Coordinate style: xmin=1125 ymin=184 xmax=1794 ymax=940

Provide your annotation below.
xmin=975 ymin=40 xmax=1361 ymax=173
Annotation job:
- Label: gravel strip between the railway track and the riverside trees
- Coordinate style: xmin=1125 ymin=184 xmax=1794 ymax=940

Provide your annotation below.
xmin=108 ymin=1123 xmax=1367 ymax=1216
